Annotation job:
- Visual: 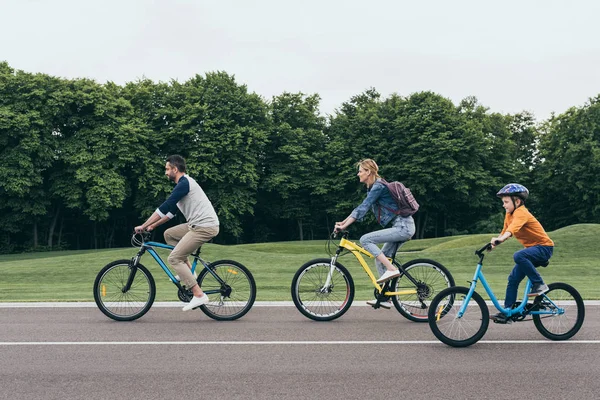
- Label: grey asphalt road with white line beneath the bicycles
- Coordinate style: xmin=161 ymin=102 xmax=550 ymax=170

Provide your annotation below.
xmin=0 ymin=306 xmax=600 ymax=400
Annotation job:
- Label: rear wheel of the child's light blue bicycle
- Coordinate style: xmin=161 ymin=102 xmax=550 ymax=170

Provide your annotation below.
xmin=532 ymin=282 xmax=585 ymax=340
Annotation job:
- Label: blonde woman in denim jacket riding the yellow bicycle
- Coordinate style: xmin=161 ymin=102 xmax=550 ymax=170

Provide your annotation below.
xmin=335 ymin=159 xmax=415 ymax=309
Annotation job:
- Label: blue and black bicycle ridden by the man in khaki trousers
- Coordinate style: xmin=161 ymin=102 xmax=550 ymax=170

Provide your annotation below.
xmin=94 ymin=233 xmax=256 ymax=321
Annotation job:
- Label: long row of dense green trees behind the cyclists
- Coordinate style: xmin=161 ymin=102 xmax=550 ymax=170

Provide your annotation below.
xmin=0 ymin=62 xmax=600 ymax=253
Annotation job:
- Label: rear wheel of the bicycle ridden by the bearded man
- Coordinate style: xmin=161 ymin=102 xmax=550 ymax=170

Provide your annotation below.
xmin=197 ymin=260 xmax=256 ymax=321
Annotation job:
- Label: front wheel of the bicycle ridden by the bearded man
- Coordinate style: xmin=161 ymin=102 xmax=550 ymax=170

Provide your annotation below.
xmin=94 ymin=260 xmax=156 ymax=321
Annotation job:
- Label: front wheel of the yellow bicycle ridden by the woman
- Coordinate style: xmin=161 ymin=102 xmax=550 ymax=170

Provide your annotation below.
xmin=292 ymin=258 xmax=354 ymax=321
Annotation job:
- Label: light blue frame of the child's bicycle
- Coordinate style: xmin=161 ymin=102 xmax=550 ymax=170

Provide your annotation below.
xmin=458 ymin=245 xmax=565 ymax=319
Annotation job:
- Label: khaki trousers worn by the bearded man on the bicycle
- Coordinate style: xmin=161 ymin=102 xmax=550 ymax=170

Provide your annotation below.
xmin=165 ymin=224 xmax=219 ymax=289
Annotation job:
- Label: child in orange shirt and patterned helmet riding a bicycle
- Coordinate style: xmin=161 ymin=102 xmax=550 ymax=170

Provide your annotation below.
xmin=491 ymin=183 xmax=554 ymax=323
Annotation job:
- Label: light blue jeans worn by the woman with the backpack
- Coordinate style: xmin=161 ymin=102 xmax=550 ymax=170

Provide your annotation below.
xmin=360 ymin=216 xmax=415 ymax=276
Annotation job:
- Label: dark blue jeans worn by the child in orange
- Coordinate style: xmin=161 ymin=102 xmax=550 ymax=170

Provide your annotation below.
xmin=504 ymin=245 xmax=554 ymax=308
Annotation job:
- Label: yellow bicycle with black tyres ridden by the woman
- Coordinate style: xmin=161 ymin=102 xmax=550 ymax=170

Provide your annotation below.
xmin=292 ymin=231 xmax=454 ymax=322
